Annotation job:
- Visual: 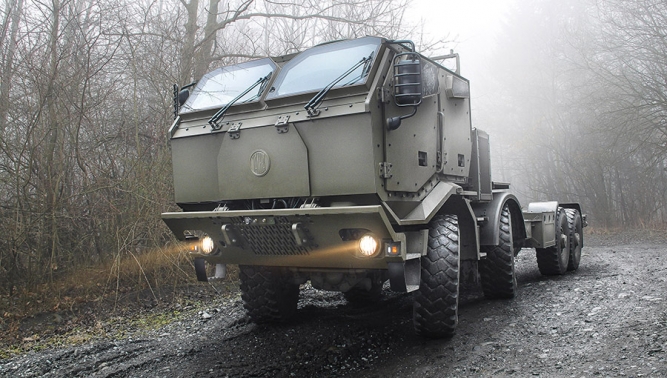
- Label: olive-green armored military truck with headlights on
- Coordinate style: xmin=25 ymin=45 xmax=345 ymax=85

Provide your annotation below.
xmin=162 ymin=37 xmax=585 ymax=338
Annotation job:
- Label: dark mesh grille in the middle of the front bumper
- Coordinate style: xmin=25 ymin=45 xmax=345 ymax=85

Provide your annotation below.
xmin=232 ymin=217 xmax=313 ymax=256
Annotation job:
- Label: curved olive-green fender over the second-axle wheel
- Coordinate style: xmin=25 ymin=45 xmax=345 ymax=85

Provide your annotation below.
xmin=472 ymin=190 xmax=528 ymax=253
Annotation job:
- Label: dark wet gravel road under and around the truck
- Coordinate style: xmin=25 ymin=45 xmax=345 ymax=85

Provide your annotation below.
xmin=0 ymin=237 xmax=667 ymax=377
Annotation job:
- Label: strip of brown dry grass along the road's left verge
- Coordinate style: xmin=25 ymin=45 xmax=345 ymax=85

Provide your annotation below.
xmin=0 ymin=239 xmax=243 ymax=358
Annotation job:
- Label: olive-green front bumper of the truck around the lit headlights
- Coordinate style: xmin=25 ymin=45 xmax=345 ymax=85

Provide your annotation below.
xmin=162 ymin=205 xmax=406 ymax=269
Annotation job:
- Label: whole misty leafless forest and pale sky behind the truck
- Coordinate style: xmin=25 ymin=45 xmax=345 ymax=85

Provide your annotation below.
xmin=0 ymin=0 xmax=667 ymax=295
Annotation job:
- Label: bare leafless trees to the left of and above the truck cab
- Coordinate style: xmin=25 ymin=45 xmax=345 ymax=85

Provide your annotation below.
xmin=0 ymin=0 xmax=426 ymax=292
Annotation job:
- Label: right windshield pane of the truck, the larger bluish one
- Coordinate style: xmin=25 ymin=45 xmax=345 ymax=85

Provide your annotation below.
xmin=266 ymin=37 xmax=382 ymax=100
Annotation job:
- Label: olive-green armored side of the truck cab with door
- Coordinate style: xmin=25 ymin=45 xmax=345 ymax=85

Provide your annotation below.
xmin=385 ymin=61 xmax=472 ymax=193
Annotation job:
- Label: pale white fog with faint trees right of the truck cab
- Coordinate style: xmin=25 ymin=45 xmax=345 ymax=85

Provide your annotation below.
xmin=408 ymin=0 xmax=667 ymax=226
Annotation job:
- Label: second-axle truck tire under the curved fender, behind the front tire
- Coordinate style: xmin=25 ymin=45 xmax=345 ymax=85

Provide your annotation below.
xmin=479 ymin=205 xmax=517 ymax=299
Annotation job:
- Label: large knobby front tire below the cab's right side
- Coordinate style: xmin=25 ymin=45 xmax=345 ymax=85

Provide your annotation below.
xmin=412 ymin=215 xmax=459 ymax=338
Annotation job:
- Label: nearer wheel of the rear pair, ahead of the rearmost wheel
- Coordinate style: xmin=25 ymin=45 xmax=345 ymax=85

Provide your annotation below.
xmin=535 ymin=207 xmax=570 ymax=276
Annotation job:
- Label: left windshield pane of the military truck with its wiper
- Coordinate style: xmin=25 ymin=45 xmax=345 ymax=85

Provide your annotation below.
xmin=181 ymin=58 xmax=276 ymax=113
